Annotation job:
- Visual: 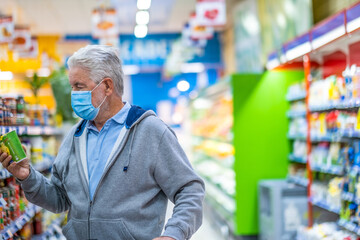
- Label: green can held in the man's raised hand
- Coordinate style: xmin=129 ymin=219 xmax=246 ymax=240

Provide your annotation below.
xmin=1 ymin=130 xmax=26 ymax=162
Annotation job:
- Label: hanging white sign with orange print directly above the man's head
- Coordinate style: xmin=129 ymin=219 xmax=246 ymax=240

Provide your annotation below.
xmin=91 ymin=8 xmax=119 ymax=38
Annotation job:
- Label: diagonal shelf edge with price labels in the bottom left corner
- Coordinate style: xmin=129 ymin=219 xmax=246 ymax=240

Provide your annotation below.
xmin=0 ymin=203 xmax=41 ymax=240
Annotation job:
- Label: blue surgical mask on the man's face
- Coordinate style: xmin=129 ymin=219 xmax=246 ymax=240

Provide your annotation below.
xmin=71 ymin=81 xmax=107 ymax=120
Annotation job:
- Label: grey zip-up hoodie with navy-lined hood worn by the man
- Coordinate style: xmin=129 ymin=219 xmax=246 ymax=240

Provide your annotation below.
xmin=20 ymin=106 xmax=204 ymax=240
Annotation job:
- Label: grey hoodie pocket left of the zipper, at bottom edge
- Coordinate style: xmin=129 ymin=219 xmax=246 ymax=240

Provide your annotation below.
xmin=63 ymin=219 xmax=88 ymax=240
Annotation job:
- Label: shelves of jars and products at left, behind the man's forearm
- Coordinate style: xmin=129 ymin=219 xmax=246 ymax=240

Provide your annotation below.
xmin=0 ymin=95 xmax=63 ymax=239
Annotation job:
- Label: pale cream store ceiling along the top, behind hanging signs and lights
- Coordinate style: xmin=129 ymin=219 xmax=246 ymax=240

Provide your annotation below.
xmin=0 ymin=0 xmax=196 ymax=35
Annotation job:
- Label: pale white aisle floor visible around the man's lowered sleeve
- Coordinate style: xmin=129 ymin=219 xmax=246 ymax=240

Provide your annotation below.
xmin=165 ymin=202 xmax=225 ymax=240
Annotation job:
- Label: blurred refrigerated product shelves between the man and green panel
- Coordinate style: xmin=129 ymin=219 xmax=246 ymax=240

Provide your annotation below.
xmin=191 ymin=82 xmax=236 ymax=231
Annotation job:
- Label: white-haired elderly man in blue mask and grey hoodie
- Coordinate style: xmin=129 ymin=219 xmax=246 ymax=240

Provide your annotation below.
xmin=0 ymin=45 xmax=204 ymax=240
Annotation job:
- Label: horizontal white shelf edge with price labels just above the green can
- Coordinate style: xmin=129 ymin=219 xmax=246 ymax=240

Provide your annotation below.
xmin=0 ymin=126 xmax=61 ymax=136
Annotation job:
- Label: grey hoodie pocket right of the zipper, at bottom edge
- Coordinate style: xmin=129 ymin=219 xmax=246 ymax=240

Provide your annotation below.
xmin=90 ymin=220 xmax=135 ymax=240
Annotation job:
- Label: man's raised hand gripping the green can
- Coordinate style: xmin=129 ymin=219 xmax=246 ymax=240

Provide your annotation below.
xmin=0 ymin=147 xmax=30 ymax=180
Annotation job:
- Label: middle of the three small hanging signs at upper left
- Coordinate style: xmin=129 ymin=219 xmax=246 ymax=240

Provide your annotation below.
xmin=10 ymin=26 xmax=31 ymax=52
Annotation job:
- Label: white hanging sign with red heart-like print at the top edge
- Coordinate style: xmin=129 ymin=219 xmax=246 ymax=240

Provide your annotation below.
xmin=196 ymin=0 xmax=226 ymax=26
